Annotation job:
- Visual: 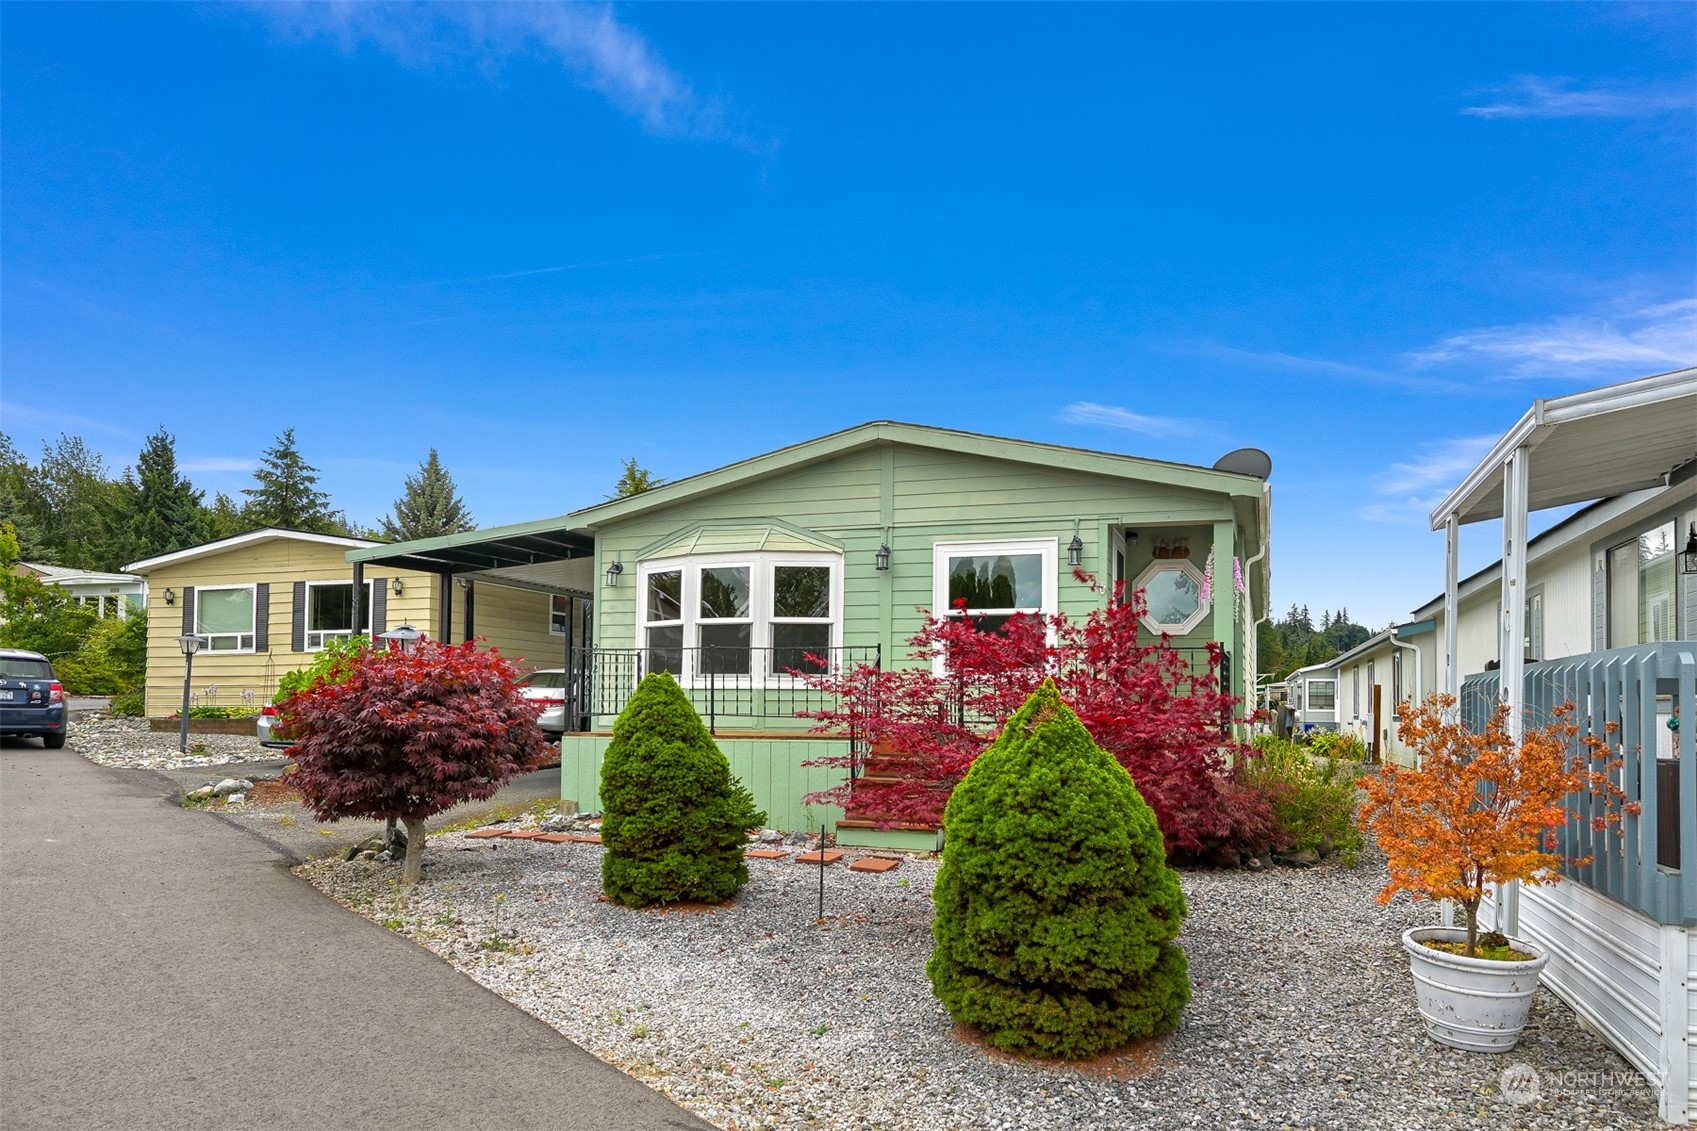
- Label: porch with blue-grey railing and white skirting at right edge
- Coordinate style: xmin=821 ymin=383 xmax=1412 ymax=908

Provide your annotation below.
xmin=1461 ymin=640 xmax=1697 ymax=1123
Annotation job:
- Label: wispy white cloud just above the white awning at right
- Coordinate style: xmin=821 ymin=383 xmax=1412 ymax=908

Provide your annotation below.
xmin=1407 ymin=299 xmax=1697 ymax=377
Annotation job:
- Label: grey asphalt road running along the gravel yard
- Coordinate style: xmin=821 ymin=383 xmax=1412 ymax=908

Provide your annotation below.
xmin=0 ymin=742 xmax=709 ymax=1131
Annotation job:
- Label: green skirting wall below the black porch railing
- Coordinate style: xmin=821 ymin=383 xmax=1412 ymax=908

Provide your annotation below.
xmin=560 ymin=734 xmax=849 ymax=832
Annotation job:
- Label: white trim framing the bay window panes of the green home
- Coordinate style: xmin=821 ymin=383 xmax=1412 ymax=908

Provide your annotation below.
xmin=635 ymin=550 xmax=843 ymax=688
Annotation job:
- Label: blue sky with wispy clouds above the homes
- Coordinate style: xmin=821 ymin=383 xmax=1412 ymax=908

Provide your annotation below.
xmin=0 ymin=3 xmax=1697 ymax=627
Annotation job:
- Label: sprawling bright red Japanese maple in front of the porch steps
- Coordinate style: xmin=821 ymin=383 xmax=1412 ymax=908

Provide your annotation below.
xmin=809 ymin=572 xmax=1251 ymax=852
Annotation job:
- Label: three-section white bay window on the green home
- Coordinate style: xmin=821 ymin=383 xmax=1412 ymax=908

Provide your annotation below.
xmin=638 ymin=554 xmax=842 ymax=681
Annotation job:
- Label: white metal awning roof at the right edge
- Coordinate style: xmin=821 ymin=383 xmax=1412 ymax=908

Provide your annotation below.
xmin=1432 ymin=369 xmax=1697 ymax=530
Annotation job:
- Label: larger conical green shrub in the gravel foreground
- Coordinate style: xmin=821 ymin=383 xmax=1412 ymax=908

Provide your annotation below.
xmin=927 ymin=679 xmax=1190 ymax=1056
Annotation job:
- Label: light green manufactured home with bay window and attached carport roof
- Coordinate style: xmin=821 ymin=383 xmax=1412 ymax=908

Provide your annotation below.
xmin=348 ymin=421 xmax=1271 ymax=844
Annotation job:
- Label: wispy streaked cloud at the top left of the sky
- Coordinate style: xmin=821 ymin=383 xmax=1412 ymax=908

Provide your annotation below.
xmin=258 ymin=0 xmax=770 ymax=153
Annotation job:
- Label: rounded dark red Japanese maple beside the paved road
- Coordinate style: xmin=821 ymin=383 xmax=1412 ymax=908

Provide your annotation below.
xmin=280 ymin=640 xmax=553 ymax=883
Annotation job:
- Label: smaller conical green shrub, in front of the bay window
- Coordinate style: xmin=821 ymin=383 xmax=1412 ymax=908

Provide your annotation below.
xmin=601 ymin=671 xmax=765 ymax=907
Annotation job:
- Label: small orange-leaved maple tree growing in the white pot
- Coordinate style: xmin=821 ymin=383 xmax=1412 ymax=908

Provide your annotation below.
xmin=1359 ymin=695 xmax=1638 ymax=956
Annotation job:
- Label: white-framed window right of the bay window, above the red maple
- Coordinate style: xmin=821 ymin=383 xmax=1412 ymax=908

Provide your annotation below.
xmin=932 ymin=538 xmax=1057 ymax=632
